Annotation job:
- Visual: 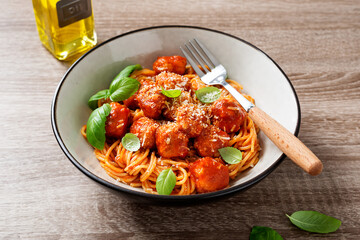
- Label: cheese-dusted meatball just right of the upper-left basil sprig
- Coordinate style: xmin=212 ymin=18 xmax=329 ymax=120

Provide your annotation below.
xmin=136 ymin=80 xmax=166 ymax=119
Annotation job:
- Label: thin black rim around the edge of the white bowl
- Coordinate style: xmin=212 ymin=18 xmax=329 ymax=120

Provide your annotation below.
xmin=51 ymin=25 xmax=301 ymax=201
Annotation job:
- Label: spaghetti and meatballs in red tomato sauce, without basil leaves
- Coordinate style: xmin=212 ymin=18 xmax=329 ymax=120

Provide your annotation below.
xmin=81 ymin=56 xmax=260 ymax=195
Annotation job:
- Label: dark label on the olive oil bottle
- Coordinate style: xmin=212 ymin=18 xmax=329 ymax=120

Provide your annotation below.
xmin=56 ymin=0 xmax=92 ymax=28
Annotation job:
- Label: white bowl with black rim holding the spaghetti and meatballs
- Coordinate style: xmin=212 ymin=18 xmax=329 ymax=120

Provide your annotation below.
xmin=51 ymin=26 xmax=300 ymax=201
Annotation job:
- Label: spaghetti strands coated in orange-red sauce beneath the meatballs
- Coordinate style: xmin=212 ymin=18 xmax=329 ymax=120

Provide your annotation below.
xmin=81 ymin=56 xmax=260 ymax=195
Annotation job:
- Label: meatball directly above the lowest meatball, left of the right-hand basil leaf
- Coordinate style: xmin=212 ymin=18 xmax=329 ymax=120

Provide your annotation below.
xmin=194 ymin=125 xmax=230 ymax=157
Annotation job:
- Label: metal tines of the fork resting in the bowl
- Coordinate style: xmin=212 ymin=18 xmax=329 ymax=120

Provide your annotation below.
xmin=180 ymin=38 xmax=220 ymax=77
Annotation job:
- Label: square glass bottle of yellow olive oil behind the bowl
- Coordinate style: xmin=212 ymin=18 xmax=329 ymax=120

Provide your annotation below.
xmin=33 ymin=0 xmax=97 ymax=60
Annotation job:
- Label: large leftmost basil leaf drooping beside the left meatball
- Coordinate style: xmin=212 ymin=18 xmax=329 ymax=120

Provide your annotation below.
xmin=86 ymin=103 xmax=111 ymax=150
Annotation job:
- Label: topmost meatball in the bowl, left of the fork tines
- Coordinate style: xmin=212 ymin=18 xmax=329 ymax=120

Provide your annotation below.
xmin=153 ymin=56 xmax=186 ymax=74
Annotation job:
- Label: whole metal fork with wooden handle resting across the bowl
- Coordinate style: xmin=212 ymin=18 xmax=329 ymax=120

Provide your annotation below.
xmin=180 ymin=39 xmax=323 ymax=176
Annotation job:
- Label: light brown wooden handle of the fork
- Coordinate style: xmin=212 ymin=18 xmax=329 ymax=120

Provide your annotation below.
xmin=249 ymin=107 xmax=323 ymax=176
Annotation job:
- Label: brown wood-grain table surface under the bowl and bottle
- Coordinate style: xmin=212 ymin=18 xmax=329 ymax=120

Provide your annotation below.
xmin=0 ymin=0 xmax=360 ymax=239
